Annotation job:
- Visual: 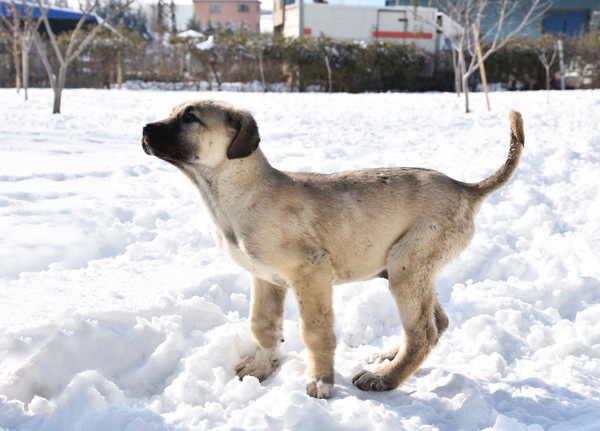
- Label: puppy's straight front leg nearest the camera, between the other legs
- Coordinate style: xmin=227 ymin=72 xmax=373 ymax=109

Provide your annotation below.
xmin=293 ymin=275 xmax=335 ymax=398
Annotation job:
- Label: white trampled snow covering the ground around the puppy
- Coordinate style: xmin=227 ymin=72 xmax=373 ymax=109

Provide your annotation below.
xmin=0 ymin=89 xmax=600 ymax=431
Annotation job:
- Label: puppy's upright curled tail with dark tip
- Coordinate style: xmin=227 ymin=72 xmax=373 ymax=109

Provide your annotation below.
xmin=471 ymin=111 xmax=525 ymax=199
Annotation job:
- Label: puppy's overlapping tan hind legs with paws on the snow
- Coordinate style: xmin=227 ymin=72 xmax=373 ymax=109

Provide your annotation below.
xmin=352 ymin=234 xmax=448 ymax=391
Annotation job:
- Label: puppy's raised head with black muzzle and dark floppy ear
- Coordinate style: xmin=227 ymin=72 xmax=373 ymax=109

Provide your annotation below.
xmin=142 ymin=100 xmax=260 ymax=168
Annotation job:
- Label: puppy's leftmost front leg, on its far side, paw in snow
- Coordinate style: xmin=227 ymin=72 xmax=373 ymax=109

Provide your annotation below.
xmin=235 ymin=278 xmax=287 ymax=381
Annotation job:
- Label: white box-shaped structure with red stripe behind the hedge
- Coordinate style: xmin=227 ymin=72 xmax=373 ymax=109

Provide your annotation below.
xmin=273 ymin=0 xmax=461 ymax=52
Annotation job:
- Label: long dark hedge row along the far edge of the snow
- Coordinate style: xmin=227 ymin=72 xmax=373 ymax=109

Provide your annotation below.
xmin=0 ymin=31 xmax=600 ymax=93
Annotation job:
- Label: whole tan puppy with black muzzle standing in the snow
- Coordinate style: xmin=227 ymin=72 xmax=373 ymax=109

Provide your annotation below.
xmin=142 ymin=101 xmax=524 ymax=398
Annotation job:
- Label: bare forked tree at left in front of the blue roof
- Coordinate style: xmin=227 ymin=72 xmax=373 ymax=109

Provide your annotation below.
xmin=33 ymin=0 xmax=134 ymax=114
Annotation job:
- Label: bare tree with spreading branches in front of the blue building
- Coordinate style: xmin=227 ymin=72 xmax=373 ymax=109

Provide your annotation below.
xmin=429 ymin=0 xmax=550 ymax=112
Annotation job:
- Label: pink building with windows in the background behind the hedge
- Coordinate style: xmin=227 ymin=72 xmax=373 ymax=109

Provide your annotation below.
xmin=193 ymin=0 xmax=260 ymax=33
